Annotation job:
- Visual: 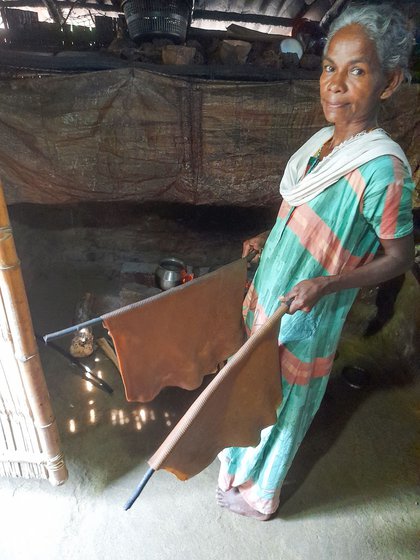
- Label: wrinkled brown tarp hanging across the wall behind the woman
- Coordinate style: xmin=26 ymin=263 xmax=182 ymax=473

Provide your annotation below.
xmin=0 ymin=68 xmax=420 ymax=206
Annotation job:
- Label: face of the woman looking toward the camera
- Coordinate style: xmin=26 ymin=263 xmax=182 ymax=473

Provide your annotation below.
xmin=320 ymin=25 xmax=386 ymax=130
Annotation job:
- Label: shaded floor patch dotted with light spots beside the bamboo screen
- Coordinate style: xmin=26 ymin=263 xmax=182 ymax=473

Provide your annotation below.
xmin=41 ymin=334 xmax=218 ymax=494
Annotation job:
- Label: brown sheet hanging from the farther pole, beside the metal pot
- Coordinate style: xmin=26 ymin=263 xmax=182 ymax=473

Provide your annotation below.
xmin=102 ymin=259 xmax=247 ymax=402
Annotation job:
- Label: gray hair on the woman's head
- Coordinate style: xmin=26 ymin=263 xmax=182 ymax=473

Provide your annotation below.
xmin=324 ymin=4 xmax=414 ymax=81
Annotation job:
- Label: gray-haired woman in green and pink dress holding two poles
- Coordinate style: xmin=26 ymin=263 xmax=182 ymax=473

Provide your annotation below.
xmin=217 ymin=5 xmax=414 ymax=520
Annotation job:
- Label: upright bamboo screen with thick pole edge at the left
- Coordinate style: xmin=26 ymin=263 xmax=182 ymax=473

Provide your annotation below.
xmin=0 ymin=184 xmax=67 ymax=486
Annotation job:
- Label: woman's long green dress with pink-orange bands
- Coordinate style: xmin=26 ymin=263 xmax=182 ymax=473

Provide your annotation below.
xmin=219 ymin=156 xmax=414 ymax=514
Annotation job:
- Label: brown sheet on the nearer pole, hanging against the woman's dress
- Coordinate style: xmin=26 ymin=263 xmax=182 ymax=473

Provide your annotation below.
xmin=148 ymin=305 xmax=288 ymax=480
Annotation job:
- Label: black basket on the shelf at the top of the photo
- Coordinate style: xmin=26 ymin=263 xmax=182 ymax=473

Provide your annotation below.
xmin=123 ymin=0 xmax=192 ymax=43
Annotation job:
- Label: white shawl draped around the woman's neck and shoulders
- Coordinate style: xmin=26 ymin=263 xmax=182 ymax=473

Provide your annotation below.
xmin=280 ymin=126 xmax=411 ymax=206
